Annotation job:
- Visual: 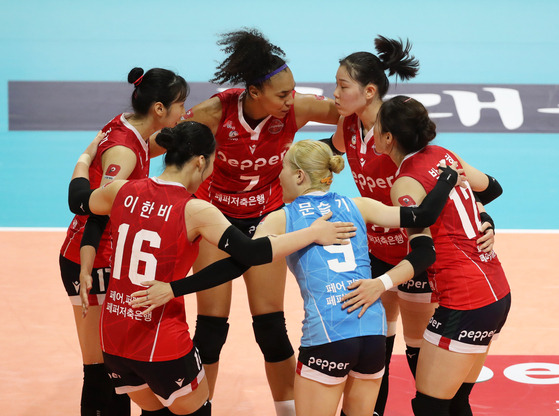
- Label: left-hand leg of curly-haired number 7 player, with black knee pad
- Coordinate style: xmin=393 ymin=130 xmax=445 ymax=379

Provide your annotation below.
xmin=192 ymin=239 xmax=232 ymax=399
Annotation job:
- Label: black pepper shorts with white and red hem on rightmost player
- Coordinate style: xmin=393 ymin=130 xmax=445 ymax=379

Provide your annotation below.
xmin=423 ymin=293 xmax=511 ymax=354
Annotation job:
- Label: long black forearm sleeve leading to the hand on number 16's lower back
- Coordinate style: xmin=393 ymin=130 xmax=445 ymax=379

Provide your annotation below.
xmin=171 ymin=257 xmax=250 ymax=297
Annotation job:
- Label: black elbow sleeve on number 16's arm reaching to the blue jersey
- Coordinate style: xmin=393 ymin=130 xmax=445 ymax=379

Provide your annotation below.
xmin=217 ymin=225 xmax=274 ymax=266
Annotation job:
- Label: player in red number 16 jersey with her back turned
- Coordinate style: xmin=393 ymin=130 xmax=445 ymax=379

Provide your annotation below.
xmin=69 ymin=121 xmax=355 ymax=416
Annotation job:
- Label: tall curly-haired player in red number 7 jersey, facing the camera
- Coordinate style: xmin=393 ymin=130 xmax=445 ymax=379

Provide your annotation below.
xmin=186 ymin=30 xmax=339 ymax=415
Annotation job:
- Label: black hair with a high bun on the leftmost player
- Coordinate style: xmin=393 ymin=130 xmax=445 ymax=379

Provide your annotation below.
xmin=128 ymin=67 xmax=189 ymax=116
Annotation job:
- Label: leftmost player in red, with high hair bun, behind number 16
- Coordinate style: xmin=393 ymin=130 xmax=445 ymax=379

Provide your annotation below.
xmin=60 ymin=68 xmax=188 ymax=416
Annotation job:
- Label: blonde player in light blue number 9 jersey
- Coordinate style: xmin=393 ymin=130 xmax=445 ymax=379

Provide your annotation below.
xmin=255 ymin=140 xmax=463 ymax=416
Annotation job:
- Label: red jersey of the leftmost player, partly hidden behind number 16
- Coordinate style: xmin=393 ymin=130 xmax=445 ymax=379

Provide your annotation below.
xmin=60 ymin=114 xmax=149 ymax=268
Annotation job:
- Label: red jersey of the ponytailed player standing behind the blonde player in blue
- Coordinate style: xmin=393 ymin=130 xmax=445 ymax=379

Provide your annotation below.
xmin=343 ymin=114 xmax=408 ymax=264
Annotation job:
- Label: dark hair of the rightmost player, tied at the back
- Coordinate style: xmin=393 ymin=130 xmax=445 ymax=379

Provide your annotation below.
xmin=378 ymin=95 xmax=437 ymax=154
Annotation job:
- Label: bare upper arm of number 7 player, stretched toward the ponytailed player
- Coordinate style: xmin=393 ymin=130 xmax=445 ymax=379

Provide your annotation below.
xmin=293 ymin=92 xmax=340 ymax=128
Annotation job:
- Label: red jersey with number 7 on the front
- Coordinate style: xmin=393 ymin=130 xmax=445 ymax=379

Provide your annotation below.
xmin=196 ymin=88 xmax=297 ymax=218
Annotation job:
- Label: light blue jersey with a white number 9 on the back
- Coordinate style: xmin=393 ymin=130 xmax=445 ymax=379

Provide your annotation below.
xmin=283 ymin=192 xmax=386 ymax=347
